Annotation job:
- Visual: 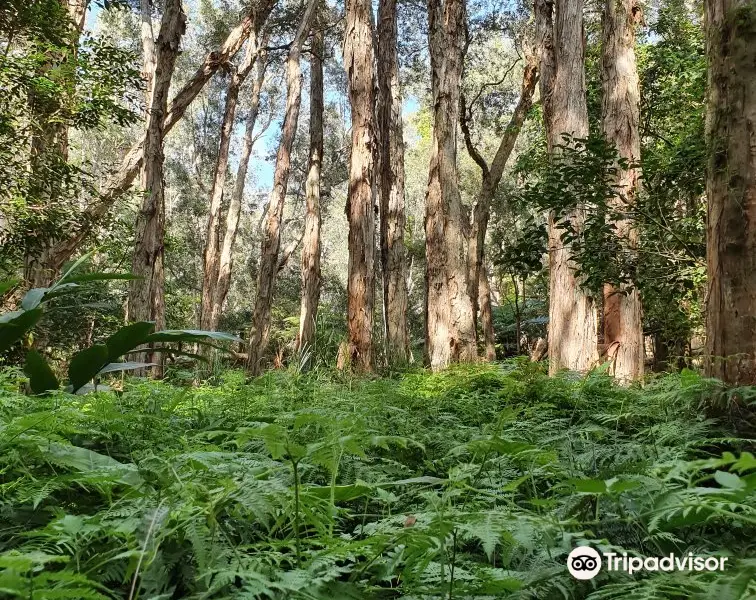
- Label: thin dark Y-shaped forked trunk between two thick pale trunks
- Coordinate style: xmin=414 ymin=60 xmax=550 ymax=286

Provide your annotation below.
xmin=460 ymin=53 xmax=538 ymax=360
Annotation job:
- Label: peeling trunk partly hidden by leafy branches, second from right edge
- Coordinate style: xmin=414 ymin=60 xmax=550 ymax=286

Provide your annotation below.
xmin=602 ymin=0 xmax=645 ymax=382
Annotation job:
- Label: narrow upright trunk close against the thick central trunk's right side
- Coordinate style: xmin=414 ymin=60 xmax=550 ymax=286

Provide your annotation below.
xmin=377 ymin=0 xmax=412 ymax=364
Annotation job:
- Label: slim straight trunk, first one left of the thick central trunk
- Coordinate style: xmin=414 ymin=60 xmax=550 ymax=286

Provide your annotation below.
xmin=296 ymin=30 xmax=324 ymax=364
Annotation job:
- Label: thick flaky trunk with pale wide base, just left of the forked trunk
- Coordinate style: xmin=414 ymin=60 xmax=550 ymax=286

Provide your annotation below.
xmin=425 ymin=0 xmax=477 ymax=370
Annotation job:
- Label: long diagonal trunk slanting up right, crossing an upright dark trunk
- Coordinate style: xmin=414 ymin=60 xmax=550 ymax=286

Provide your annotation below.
xmin=25 ymin=0 xmax=275 ymax=287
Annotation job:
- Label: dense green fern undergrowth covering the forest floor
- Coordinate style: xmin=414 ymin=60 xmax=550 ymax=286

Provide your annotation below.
xmin=0 ymin=362 xmax=756 ymax=600
